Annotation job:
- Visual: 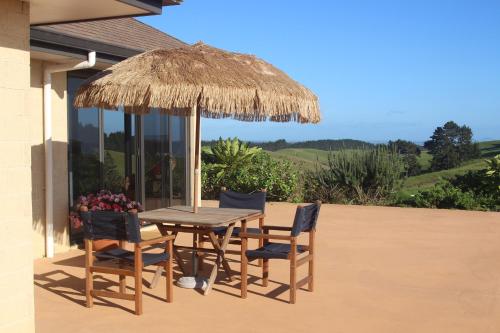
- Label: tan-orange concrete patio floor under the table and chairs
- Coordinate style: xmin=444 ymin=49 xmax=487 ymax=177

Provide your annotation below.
xmin=34 ymin=202 xmax=500 ymax=333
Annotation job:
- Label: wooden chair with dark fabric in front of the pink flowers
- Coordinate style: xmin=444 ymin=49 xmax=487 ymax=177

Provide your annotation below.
xmin=80 ymin=211 xmax=175 ymax=315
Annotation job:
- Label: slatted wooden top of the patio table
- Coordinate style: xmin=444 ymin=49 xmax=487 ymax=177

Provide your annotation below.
xmin=139 ymin=206 xmax=264 ymax=227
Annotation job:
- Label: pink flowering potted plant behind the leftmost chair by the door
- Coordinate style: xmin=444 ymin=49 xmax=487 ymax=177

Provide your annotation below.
xmin=70 ymin=190 xmax=142 ymax=251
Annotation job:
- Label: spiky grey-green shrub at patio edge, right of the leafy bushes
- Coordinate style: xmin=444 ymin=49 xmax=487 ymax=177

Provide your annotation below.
xmin=304 ymin=147 xmax=405 ymax=204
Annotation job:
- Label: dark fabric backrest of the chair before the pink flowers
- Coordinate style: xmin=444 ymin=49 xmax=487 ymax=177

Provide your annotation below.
xmin=80 ymin=211 xmax=141 ymax=243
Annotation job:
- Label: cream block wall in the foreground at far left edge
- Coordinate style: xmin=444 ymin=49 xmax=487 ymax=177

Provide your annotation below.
xmin=0 ymin=0 xmax=35 ymax=333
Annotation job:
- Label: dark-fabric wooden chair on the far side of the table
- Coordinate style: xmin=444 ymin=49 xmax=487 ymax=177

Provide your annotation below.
xmin=199 ymin=187 xmax=267 ymax=264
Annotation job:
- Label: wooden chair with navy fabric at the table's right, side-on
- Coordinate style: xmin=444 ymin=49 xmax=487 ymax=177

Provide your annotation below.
xmin=240 ymin=201 xmax=321 ymax=304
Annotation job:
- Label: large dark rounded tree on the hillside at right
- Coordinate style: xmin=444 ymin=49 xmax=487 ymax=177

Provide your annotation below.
xmin=424 ymin=121 xmax=480 ymax=170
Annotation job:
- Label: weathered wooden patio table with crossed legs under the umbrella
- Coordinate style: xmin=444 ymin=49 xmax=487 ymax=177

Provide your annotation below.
xmin=139 ymin=206 xmax=264 ymax=295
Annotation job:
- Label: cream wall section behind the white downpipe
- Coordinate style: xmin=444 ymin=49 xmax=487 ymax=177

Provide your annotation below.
xmin=28 ymin=59 xmax=69 ymax=258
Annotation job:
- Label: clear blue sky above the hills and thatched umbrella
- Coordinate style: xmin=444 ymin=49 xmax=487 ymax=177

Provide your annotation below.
xmin=141 ymin=0 xmax=500 ymax=142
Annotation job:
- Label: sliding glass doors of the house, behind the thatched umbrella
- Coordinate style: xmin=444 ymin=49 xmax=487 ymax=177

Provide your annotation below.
xmin=68 ymin=72 xmax=188 ymax=240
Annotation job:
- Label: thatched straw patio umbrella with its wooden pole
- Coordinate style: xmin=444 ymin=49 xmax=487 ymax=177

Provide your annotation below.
xmin=74 ymin=43 xmax=320 ymax=212
